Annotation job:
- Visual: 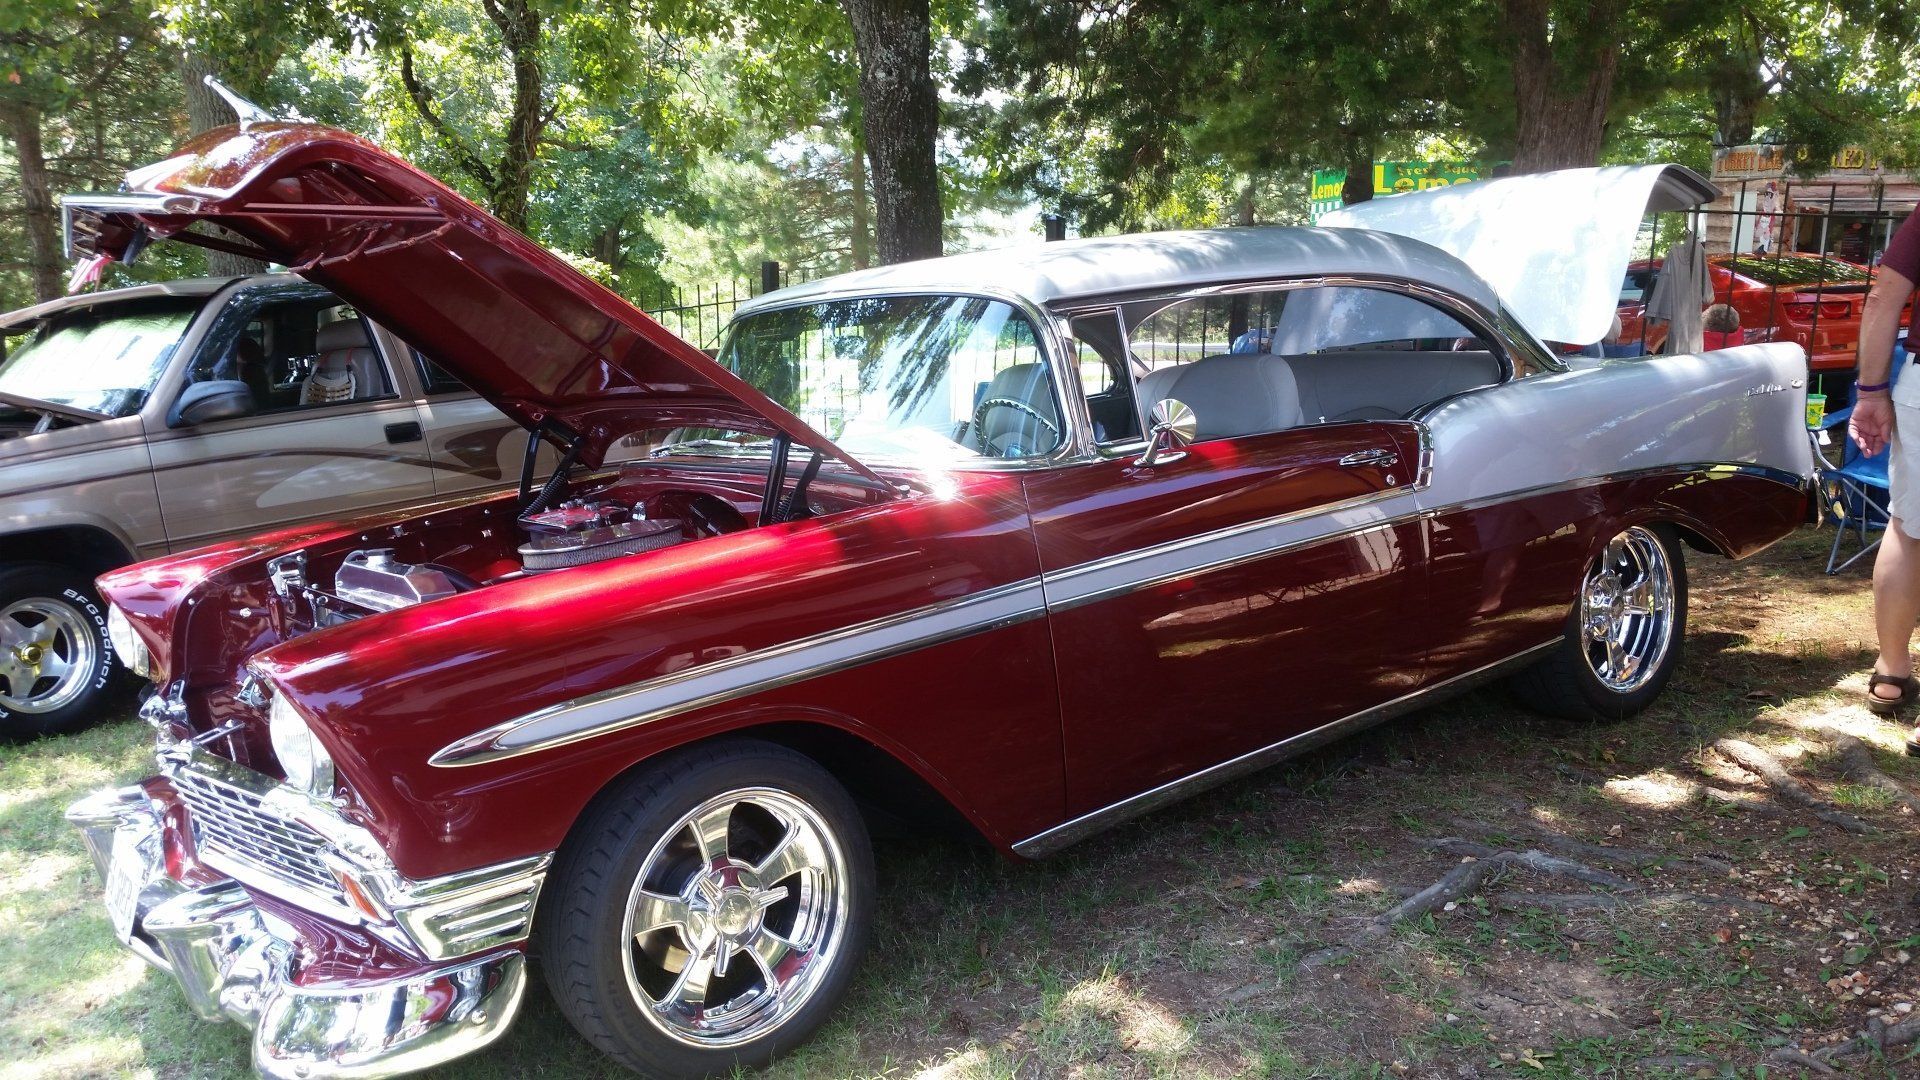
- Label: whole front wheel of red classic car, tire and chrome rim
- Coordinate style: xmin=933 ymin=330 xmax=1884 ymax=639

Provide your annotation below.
xmin=536 ymin=740 xmax=874 ymax=1078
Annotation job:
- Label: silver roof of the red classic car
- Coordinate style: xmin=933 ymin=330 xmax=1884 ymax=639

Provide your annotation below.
xmin=735 ymin=225 xmax=1500 ymax=315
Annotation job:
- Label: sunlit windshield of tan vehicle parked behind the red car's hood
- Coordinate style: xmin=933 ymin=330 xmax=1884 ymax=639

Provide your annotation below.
xmin=0 ymin=298 xmax=198 ymax=417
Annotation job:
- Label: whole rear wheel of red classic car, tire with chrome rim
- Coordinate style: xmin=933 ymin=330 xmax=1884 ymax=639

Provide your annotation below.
xmin=1513 ymin=525 xmax=1686 ymax=721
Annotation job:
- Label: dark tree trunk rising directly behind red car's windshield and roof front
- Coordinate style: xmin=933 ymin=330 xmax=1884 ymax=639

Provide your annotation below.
xmin=841 ymin=0 xmax=943 ymax=263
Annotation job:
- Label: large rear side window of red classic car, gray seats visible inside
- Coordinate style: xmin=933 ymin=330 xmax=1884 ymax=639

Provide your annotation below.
xmin=1127 ymin=284 xmax=1505 ymax=438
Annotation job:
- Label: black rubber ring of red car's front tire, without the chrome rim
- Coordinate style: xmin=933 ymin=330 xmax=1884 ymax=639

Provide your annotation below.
xmin=536 ymin=740 xmax=876 ymax=1076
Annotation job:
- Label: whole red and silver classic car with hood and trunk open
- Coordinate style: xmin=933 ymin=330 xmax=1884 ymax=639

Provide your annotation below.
xmin=65 ymin=123 xmax=1811 ymax=1078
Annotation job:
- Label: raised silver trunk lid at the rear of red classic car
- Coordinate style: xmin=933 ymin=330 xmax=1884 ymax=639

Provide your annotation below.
xmin=1319 ymin=165 xmax=1718 ymax=346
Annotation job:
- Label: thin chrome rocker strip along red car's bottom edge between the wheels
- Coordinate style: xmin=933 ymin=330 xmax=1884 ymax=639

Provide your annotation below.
xmin=1014 ymin=638 xmax=1565 ymax=859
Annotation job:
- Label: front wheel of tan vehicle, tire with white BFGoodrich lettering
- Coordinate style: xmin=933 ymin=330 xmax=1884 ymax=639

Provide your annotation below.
xmin=0 ymin=563 xmax=121 ymax=740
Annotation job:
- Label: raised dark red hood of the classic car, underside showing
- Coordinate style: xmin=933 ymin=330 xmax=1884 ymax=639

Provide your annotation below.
xmin=61 ymin=123 xmax=879 ymax=480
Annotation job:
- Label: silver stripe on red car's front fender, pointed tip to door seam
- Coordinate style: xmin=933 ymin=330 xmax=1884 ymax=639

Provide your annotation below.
xmin=428 ymin=578 xmax=1046 ymax=767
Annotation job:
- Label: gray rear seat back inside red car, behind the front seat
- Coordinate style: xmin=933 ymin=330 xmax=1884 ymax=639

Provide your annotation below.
xmin=1277 ymin=350 xmax=1501 ymax=423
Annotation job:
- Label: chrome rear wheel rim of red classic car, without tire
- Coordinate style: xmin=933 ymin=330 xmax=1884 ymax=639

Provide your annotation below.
xmin=1580 ymin=525 xmax=1674 ymax=694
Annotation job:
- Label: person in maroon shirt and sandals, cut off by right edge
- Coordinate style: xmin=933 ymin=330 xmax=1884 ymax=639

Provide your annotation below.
xmin=1849 ymin=213 xmax=1920 ymax=737
